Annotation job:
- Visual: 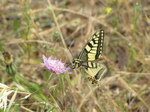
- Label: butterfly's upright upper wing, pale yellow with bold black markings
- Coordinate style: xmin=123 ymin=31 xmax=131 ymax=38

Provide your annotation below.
xmin=77 ymin=30 xmax=104 ymax=62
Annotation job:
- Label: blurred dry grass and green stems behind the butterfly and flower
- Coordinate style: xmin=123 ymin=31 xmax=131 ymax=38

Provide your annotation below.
xmin=0 ymin=0 xmax=150 ymax=112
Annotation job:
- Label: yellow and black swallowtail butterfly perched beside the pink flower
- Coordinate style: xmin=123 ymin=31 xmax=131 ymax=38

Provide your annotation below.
xmin=72 ymin=30 xmax=107 ymax=84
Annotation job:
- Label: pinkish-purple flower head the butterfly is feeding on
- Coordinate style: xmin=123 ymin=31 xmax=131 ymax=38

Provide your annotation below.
xmin=43 ymin=55 xmax=70 ymax=74
